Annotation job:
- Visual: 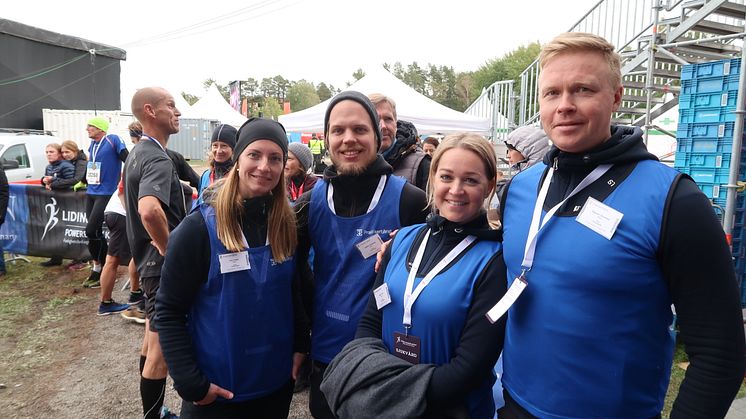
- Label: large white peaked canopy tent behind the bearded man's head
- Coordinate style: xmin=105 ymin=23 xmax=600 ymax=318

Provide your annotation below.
xmin=279 ymin=67 xmax=490 ymax=135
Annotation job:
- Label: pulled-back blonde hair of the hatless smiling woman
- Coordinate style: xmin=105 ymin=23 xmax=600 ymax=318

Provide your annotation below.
xmin=427 ymin=132 xmax=497 ymax=210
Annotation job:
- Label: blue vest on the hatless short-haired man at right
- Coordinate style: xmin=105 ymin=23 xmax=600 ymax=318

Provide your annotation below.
xmin=502 ymin=160 xmax=678 ymax=418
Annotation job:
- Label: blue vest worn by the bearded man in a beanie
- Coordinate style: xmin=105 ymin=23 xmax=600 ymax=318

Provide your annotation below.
xmin=308 ymin=176 xmax=406 ymax=364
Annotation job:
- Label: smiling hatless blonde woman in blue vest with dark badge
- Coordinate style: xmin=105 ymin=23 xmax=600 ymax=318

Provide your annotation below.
xmin=356 ymin=134 xmax=506 ymax=418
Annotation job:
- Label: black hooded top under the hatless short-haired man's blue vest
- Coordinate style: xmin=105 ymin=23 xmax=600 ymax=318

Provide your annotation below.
xmin=501 ymin=126 xmax=746 ymax=418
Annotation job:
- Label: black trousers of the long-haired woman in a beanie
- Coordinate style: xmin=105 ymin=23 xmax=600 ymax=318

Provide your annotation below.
xmin=179 ymin=379 xmax=293 ymax=419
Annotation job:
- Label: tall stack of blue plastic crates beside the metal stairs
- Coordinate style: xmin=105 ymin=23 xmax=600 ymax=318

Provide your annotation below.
xmin=674 ymin=58 xmax=746 ymax=303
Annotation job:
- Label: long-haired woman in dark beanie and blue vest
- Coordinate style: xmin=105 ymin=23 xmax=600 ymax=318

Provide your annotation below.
xmin=156 ymin=118 xmax=309 ymax=418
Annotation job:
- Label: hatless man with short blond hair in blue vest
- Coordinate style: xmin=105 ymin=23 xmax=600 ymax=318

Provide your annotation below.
xmin=499 ymin=33 xmax=745 ymax=418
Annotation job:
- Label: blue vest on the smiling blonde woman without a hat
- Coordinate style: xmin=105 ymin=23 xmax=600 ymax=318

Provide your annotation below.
xmin=381 ymin=224 xmax=501 ymax=419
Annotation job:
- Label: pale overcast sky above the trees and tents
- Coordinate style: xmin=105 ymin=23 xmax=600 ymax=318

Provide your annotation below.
xmin=0 ymin=0 xmax=597 ymax=109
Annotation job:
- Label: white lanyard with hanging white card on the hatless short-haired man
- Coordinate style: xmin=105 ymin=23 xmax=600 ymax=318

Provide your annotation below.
xmin=486 ymin=164 xmax=613 ymax=323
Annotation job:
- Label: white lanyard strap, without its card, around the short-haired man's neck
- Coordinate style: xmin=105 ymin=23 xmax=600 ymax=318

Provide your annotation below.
xmin=521 ymin=164 xmax=613 ymax=279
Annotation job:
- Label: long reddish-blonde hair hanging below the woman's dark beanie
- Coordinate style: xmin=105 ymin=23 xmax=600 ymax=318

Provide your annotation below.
xmin=210 ymin=159 xmax=298 ymax=262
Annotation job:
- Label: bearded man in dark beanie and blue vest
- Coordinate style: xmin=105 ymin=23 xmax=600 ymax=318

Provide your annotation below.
xmin=295 ymin=91 xmax=427 ymax=419
